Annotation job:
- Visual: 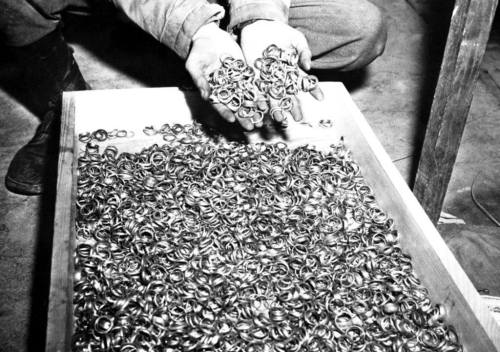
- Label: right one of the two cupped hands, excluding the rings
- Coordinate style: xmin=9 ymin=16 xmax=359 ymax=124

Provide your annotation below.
xmin=240 ymin=20 xmax=323 ymax=122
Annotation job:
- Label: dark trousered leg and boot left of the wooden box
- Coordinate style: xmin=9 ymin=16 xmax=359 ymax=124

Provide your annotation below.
xmin=0 ymin=0 xmax=86 ymax=194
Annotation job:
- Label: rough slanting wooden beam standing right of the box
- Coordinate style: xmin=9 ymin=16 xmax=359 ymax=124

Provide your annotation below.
xmin=413 ymin=0 xmax=498 ymax=223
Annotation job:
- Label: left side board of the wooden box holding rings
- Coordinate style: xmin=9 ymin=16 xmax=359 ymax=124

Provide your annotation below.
xmin=45 ymin=93 xmax=76 ymax=352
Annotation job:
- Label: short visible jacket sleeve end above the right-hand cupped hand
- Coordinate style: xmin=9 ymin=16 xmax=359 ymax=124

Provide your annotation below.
xmin=228 ymin=0 xmax=290 ymax=32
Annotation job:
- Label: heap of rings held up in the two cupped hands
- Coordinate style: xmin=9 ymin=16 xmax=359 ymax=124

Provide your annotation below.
xmin=208 ymin=44 xmax=318 ymax=124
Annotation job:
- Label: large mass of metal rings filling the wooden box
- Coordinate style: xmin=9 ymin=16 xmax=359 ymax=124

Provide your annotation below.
xmin=73 ymin=125 xmax=462 ymax=352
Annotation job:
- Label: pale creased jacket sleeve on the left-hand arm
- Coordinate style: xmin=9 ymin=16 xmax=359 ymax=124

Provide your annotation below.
xmin=111 ymin=0 xmax=224 ymax=58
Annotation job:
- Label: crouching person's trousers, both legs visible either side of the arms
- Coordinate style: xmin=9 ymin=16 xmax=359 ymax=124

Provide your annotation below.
xmin=0 ymin=0 xmax=387 ymax=70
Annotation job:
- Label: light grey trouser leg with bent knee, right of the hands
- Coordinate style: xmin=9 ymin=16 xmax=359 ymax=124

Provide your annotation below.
xmin=289 ymin=0 xmax=387 ymax=71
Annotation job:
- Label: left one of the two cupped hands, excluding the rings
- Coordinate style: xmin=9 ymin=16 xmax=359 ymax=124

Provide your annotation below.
xmin=186 ymin=23 xmax=254 ymax=130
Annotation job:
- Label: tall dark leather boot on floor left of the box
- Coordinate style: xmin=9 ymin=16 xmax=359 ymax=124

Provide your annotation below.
xmin=5 ymin=29 xmax=90 ymax=195
